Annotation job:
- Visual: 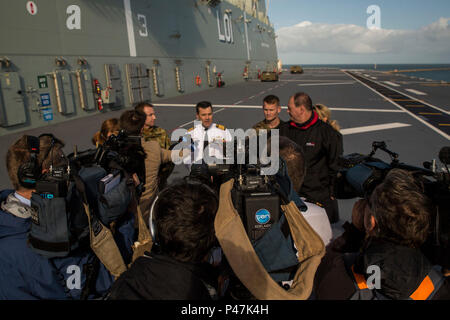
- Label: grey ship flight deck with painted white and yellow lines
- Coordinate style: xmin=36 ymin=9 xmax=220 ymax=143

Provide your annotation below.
xmin=0 ymin=69 xmax=450 ymax=235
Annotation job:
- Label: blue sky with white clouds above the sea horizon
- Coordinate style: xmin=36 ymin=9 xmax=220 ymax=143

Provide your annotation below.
xmin=266 ymin=0 xmax=450 ymax=64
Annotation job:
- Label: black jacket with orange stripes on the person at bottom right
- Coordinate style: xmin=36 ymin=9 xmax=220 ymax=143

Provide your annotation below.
xmin=313 ymin=224 xmax=450 ymax=300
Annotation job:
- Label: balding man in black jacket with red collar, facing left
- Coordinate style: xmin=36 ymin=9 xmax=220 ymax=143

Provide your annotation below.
xmin=280 ymin=92 xmax=343 ymax=223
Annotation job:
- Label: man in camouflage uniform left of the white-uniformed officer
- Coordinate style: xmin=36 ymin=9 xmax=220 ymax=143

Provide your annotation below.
xmin=134 ymin=102 xmax=175 ymax=190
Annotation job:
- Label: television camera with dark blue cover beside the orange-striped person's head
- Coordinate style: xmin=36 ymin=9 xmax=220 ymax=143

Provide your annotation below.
xmin=335 ymin=141 xmax=450 ymax=268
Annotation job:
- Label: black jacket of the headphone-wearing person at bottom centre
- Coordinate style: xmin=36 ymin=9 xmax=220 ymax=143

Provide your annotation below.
xmin=108 ymin=253 xmax=216 ymax=300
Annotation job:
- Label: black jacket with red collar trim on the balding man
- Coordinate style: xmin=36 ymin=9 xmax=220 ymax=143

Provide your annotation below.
xmin=280 ymin=112 xmax=343 ymax=203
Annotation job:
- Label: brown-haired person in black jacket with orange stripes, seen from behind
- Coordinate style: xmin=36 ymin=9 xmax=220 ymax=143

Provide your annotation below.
xmin=314 ymin=169 xmax=450 ymax=300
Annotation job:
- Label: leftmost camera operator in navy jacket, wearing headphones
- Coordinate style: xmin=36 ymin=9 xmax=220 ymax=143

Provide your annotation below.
xmin=0 ymin=134 xmax=133 ymax=300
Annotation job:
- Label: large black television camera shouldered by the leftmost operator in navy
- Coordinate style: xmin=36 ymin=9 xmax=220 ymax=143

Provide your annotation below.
xmin=29 ymin=132 xmax=145 ymax=257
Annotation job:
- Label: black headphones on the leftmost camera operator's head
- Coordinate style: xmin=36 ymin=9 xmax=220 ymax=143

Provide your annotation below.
xmin=17 ymin=133 xmax=61 ymax=189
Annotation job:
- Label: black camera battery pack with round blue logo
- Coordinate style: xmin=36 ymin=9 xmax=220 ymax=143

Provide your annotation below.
xmin=244 ymin=193 xmax=280 ymax=241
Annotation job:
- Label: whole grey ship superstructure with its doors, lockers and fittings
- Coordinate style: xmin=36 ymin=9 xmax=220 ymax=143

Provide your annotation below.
xmin=0 ymin=0 xmax=278 ymax=136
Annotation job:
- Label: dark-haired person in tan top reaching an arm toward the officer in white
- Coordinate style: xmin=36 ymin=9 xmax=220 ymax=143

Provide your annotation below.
xmin=120 ymin=110 xmax=172 ymax=221
